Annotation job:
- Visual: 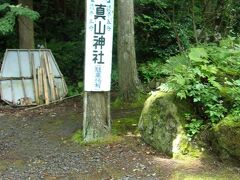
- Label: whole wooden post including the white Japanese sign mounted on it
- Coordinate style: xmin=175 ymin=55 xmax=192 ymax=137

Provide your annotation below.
xmin=83 ymin=0 xmax=114 ymax=142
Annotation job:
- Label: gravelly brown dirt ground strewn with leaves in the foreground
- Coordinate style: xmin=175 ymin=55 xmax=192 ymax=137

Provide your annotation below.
xmin=0 ymin=98 xmax=240 ymax=180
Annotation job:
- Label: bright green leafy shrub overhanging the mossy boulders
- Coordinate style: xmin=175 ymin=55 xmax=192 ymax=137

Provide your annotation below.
xmin=160 ymin=38 xmax=240 ymax=126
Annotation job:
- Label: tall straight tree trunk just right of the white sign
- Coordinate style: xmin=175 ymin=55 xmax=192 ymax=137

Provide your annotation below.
xmin=117 ymin=0 xmax=140 ymax=102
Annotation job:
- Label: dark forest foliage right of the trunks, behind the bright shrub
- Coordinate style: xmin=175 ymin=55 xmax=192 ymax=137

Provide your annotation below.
xmin=135 ymin=0 xmax=240 ymax=82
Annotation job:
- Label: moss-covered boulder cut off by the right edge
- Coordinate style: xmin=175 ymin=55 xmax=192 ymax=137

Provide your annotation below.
xmin=212 ymin=115 xmax=240 ymax=160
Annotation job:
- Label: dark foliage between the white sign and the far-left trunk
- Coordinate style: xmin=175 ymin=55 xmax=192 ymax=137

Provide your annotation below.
xmin=34 ymin=0 xmax=85 ymax=86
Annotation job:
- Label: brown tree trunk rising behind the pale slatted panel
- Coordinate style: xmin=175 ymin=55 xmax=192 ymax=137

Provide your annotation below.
xmin=18 ymin=0 xmax=34 ymax=49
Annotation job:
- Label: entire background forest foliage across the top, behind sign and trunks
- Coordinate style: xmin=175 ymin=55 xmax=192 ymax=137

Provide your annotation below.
xmin=0 ymin=0 xmax=240 ymax=97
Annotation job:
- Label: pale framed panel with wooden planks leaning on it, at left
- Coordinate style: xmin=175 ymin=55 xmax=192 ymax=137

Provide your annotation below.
xmin=0 ymin=49 xmax=67 ymax=106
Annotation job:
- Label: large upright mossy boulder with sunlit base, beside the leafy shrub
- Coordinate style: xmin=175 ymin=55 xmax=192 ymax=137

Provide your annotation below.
xmin=138 ymin=91 xmax=200 ymax=158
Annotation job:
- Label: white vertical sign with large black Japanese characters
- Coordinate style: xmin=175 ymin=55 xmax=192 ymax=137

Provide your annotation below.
xmin=84 ymin=0 xmax=114 ymax=91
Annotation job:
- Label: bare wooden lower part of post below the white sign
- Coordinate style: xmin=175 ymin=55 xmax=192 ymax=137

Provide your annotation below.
xmin=83 ymin=92 xmax=111 ymax=142
